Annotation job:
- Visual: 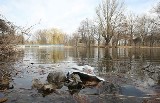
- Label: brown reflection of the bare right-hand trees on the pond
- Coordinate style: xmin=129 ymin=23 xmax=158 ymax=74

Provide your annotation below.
xmin=98 ymin=48 xmax=160 ymax=85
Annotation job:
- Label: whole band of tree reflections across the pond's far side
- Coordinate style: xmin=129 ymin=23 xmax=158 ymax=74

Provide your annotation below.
xmin=24 ymin=48 xmax=160 ymax=89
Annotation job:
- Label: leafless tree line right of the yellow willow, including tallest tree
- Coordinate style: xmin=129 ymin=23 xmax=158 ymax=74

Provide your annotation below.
xmin=72 ymin=0 xmax=160 ymax=46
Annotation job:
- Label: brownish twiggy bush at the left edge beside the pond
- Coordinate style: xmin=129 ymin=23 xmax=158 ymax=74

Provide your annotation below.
xmin=0 ymin=16 xmax=18 ymax=56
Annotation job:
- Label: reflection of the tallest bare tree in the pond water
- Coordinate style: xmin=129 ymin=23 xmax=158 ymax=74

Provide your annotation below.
xmin=98 ymin=48 xmax=131 ymax=73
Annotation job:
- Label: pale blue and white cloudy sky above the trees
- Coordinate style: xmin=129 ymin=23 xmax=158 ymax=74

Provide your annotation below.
xmin=0 ymin=0 xmax=160 ymax=34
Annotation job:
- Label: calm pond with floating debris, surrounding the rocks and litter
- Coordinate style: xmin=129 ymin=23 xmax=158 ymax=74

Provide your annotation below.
xmin=0 ymin=47 xmax=160 ymax=103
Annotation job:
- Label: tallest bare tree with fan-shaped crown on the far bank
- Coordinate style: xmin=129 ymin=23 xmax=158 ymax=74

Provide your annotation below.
xmin=96 ymin=0 xmax=124 ymax=46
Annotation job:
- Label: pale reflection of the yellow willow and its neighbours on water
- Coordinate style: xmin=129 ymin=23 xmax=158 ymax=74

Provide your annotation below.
xmin=24 ymin=48 xmax=65 ymax=63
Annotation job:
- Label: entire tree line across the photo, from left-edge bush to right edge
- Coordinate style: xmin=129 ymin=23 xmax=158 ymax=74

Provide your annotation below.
xmin=0 ymin=0 xmax=160 ymax=47
